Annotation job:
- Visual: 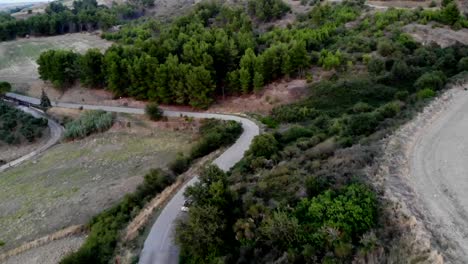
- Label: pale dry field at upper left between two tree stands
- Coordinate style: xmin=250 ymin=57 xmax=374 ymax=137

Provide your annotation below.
xmin=0 ymin=33 xmax=112 ymax=89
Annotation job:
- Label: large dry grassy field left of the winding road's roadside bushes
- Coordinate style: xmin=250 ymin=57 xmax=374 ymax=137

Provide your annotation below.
xmin=0 ymin=113 xmax=196 ymax=254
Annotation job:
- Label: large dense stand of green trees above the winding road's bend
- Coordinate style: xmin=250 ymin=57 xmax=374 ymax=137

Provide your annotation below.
xmin=38 ymin=0 xmax=358 ymax=108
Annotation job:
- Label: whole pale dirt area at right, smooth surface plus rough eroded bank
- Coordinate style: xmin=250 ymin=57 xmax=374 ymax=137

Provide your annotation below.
xmin=378 ymin=86 xmax=468 ymax=263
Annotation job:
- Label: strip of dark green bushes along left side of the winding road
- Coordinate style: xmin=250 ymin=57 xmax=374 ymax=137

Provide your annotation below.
xmin=60 ymin=119 xmax=242 ymax=264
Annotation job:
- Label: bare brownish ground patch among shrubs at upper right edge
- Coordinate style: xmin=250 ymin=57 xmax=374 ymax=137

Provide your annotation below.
xmin=403 ymin=23 xmax=468 ymax=48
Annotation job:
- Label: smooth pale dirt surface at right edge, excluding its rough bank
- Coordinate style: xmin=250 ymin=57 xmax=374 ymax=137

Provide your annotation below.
xmin=409 ymin=90 xmax=468 ymax=263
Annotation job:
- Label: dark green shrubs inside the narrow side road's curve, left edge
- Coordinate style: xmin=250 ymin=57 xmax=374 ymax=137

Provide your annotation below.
xmin=0 ymin=101 xmax=47 ymax=144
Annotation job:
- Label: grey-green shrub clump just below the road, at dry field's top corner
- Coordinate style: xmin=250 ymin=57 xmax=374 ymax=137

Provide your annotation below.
xmin=64 ymin=110 xmax=114 ymax=140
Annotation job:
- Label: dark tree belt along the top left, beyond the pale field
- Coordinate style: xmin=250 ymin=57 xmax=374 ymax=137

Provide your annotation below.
xmin=0 ymin=0 xmax=142 ymax=41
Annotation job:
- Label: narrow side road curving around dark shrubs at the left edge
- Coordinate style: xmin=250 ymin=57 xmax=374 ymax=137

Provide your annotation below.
xmin=0 ymin=100 xmax=63 ymax=172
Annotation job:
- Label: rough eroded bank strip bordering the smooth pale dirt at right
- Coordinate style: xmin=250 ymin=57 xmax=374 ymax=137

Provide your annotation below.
xmin=369 ymin=87 xmax=468 ymax=263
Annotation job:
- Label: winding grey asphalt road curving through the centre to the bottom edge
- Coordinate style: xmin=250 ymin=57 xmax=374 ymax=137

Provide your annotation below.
xmin=6 ymin=93 xmax=260 ymax=264
